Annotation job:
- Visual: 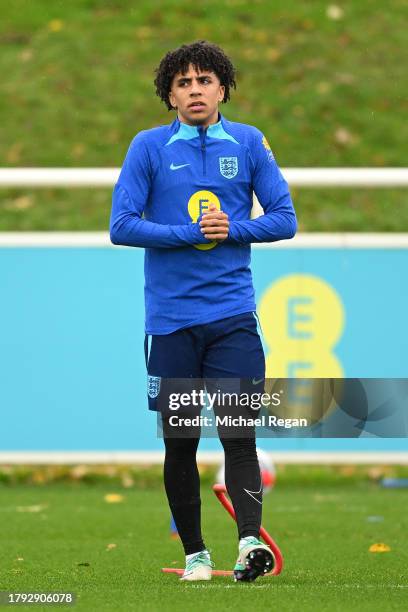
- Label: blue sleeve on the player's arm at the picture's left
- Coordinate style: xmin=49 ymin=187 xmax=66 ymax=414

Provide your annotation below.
xmin=110 ymin=133 xmax=208 ymax=248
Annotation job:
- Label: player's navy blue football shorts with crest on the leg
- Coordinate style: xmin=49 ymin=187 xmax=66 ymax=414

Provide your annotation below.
xmin=145 ymin=312 xmax=265 ymax=415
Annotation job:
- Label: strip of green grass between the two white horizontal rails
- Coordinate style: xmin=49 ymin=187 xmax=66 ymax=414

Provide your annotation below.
xmin=0 ymin=189 xmax=408 ymax=232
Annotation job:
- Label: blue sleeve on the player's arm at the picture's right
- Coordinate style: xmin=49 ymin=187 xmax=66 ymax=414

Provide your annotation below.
xmin=228 ymin=130 xmax=297 ymax=244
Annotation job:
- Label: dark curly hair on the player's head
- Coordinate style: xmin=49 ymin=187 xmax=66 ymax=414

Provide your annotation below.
xmin=154 ymin=40 xmax=236 ymax=110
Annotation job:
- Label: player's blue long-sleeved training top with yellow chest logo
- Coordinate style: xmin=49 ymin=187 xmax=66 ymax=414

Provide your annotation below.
xmin=110 ymin=115 xmax=296 ymax=335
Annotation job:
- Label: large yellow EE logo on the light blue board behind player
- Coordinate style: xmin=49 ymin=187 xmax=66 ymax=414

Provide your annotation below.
xmin=258 ymin=274 xmax=345 ymax=425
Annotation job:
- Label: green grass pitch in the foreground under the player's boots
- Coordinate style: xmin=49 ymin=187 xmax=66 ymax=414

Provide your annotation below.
xmin=0 ymin=467 xmax=408 ymax=612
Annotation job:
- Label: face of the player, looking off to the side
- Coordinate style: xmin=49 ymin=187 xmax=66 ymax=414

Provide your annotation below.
xmin=169 ymin=64 xmax=225 ymax=127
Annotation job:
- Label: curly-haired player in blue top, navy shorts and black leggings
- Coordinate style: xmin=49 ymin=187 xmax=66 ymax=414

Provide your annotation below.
xmin=110 ymin=41 xmax=297 ymax=581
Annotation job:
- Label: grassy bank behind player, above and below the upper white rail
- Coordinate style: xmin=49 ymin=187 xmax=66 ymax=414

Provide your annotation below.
xmin=0 ymin=0 xmax=408 ymax=231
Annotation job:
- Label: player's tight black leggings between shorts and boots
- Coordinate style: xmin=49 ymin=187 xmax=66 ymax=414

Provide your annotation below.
xmin=163 ymin=420 xmax=262 ymax=555
